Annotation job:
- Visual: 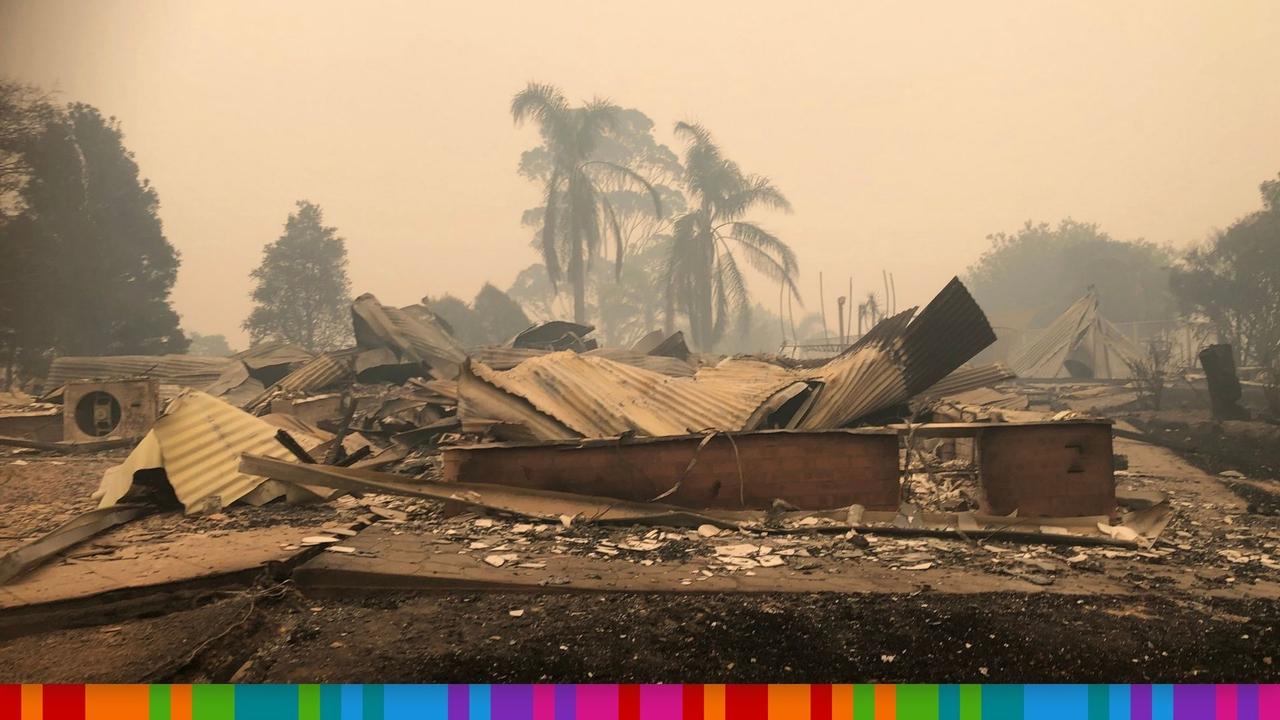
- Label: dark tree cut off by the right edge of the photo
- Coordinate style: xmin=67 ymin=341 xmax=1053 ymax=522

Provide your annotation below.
xmin=1170 ymin=176 xmax=1280 ymax=413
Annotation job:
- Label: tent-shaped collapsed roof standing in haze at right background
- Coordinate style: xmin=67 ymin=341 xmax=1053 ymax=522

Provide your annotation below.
xmin=1009 ymin=290 xmax=1143 ymax=379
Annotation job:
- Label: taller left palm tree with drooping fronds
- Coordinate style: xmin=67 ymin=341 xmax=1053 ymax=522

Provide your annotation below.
xmin=511 ymin=83 xmax=662 ymax=323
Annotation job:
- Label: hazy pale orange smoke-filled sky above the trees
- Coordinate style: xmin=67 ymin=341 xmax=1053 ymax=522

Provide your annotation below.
xmin=0 ymin=0 xmax=1280 ymax=347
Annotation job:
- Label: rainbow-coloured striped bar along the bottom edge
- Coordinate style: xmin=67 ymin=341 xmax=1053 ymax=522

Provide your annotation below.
xmin=0 ymin=685 xmax=1280 ymax=720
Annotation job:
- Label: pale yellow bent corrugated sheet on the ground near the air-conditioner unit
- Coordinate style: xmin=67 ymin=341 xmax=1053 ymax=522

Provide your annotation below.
xmin=101 ymin=389 xmax=320 ymax=512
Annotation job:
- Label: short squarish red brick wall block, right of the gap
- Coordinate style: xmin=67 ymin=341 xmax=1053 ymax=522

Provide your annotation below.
xmin=978 ymin=423 xmax=1116 ymax=518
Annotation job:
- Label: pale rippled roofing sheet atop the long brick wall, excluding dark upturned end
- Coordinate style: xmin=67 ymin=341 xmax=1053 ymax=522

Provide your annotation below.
xmin=460 ymin=351 xmax=796 ymax=439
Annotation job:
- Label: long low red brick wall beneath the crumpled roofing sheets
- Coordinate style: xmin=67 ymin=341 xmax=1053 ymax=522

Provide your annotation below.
xmin=444 ymin=432 xmax=899 ymax=510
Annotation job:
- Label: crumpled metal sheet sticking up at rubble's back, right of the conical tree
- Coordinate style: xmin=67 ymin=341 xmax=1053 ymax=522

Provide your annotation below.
xmin=351 ymin=293 xmax=466 ymax=378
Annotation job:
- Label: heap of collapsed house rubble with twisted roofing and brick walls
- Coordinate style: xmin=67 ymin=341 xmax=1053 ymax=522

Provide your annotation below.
xmin=0 ymin=274 xmax=1170 ymax=582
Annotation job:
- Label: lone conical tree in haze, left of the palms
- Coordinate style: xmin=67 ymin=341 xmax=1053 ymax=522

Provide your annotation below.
xmin=243 ymin=200 xmax=351 ymax=351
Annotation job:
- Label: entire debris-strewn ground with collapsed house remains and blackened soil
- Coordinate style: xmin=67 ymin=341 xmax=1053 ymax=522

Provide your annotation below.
xmin=0 ymin=281 xmax=1280 ymax=682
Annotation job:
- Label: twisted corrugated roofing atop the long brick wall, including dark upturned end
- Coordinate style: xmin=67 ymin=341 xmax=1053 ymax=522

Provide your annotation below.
xmin=460 ymin=279 xmax=995 ymax=439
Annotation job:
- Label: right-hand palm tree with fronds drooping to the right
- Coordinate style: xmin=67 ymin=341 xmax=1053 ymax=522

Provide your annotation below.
xmin=663 ymin=123 xmax=800 ymax=351
